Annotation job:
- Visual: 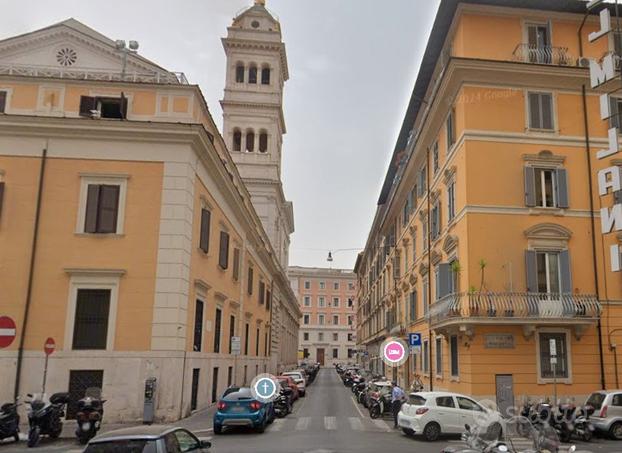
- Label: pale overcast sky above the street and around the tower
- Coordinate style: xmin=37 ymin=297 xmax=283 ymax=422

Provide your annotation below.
xmin=0 ymin=0 xmax=439 ymax=268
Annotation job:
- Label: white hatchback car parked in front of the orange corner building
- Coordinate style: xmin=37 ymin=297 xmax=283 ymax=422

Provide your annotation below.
xmin=397 ymin=392 xmax=505 ymax=441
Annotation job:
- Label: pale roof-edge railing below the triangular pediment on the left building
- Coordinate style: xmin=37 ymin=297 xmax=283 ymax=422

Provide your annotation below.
xmin=0 ymin=63 xmax=188 ymax=85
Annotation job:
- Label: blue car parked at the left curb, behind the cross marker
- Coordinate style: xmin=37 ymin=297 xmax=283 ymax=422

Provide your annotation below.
xmin=214 ymin=387 xmax=275 ymax=434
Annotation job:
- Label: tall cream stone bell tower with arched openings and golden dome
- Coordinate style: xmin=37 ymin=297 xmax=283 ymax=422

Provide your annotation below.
xmin=221 ymin=0 xmax=294 ymax=269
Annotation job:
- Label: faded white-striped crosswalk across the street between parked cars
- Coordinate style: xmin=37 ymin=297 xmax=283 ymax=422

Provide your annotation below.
xmin=269 ymin=416 xmax=393 ymax=432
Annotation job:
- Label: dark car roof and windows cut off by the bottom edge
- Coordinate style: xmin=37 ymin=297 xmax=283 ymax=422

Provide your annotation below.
xmin=84 ymin=425 xmax=212 ymax=453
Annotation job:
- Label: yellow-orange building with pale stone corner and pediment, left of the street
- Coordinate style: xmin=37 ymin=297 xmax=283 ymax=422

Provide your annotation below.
xmin=0 ymin=15 xmax=301 ymax=422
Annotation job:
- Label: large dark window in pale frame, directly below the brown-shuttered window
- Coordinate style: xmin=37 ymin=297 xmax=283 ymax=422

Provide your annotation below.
xmin=72 ymin=289 xmax=111 ymax=349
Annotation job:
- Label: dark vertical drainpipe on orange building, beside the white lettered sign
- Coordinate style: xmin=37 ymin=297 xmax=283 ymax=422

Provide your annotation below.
xmin=577 ymin=15 xmax=617 ymax=390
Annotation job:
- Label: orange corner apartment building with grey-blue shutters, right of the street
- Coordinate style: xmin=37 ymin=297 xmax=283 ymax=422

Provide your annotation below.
xmin=355 ymin=0 xmax=622 ymax=409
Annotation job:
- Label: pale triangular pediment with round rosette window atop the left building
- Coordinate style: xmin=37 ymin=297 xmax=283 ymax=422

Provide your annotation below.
xmin=0 ymin=19 xmax=173 ymax=77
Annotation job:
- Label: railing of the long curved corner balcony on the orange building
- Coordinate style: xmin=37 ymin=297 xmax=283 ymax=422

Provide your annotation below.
xmin=426 ymin=292 xmax=601 ymax=326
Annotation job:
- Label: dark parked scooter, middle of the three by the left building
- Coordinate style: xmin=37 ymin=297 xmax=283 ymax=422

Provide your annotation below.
xmin=27 ymin=393 xmax=69 ymax=448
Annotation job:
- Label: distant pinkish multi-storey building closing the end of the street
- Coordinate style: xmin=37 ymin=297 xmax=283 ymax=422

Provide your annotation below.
xmin=289 ymin=266 xmax=357 ymax=366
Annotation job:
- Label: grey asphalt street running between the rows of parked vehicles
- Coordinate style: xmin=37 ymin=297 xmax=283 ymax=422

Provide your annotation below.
xmin=0 ymin=369 xmax=622 ymax=453
